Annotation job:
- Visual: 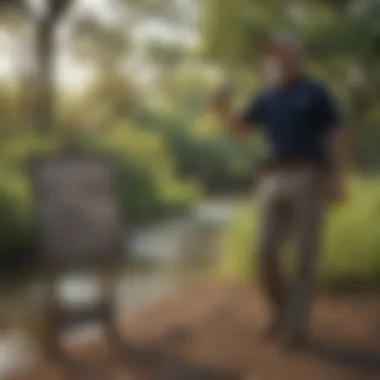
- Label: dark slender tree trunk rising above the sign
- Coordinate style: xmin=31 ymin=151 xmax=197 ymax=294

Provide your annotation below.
xmin=35 ymin=17 xmax=55 ymax=133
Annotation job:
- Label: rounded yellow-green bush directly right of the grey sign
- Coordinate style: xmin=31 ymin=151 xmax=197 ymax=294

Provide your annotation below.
xmin=88 ymin=123 xmax=199 ymax=222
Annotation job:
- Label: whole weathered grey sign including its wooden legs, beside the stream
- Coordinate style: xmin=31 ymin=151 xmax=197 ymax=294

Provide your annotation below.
xmin=30 ymin=154 xmax=124 ymax=358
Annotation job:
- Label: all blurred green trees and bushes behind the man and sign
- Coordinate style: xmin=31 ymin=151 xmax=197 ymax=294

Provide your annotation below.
xmin=0 ymin=0 xmax=380 ymax=288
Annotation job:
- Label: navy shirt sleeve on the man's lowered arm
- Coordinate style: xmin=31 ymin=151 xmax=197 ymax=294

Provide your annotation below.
xmin=316 ymin=88 xmax=341 ymax=132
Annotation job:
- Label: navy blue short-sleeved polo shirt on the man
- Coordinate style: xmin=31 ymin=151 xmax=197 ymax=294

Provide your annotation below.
xmin=243 ymin=77 xmax=340 ymax=164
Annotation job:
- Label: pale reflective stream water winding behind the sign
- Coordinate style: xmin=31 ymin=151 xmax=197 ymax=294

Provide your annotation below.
xmin=0 ymin=199 xmax=240 ymax=378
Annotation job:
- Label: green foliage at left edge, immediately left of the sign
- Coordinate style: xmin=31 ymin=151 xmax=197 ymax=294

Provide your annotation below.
xmin=0 ymin=136 xmax=56 ymax=271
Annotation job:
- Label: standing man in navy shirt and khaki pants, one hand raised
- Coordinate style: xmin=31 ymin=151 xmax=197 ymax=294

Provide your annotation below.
xmin=213 ymin=35 xmax=347 ymax=347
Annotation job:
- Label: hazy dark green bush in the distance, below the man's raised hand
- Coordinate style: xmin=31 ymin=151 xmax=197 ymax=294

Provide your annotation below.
xmin=131 ymin=110 xmax=257 ymax=194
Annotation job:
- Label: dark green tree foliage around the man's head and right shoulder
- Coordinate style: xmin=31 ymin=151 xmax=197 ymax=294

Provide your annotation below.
xmin=201 ymin=0 xmax=380 ymax=170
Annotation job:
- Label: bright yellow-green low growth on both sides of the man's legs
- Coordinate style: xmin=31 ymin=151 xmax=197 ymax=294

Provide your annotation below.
xmin=217 ymin=179 xmax=380 ymax=286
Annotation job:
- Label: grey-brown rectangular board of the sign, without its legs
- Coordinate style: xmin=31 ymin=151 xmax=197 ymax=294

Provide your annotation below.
xmin=32 ymin=156 xmax=122 ymax=265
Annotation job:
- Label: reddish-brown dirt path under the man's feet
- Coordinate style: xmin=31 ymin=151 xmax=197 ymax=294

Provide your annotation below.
xmin=7 ymin=284 xmax=380 ymax=380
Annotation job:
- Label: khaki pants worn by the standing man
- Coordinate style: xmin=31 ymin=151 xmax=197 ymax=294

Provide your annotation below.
xmin=258 ymin=167 xmax=323 ymax=334
